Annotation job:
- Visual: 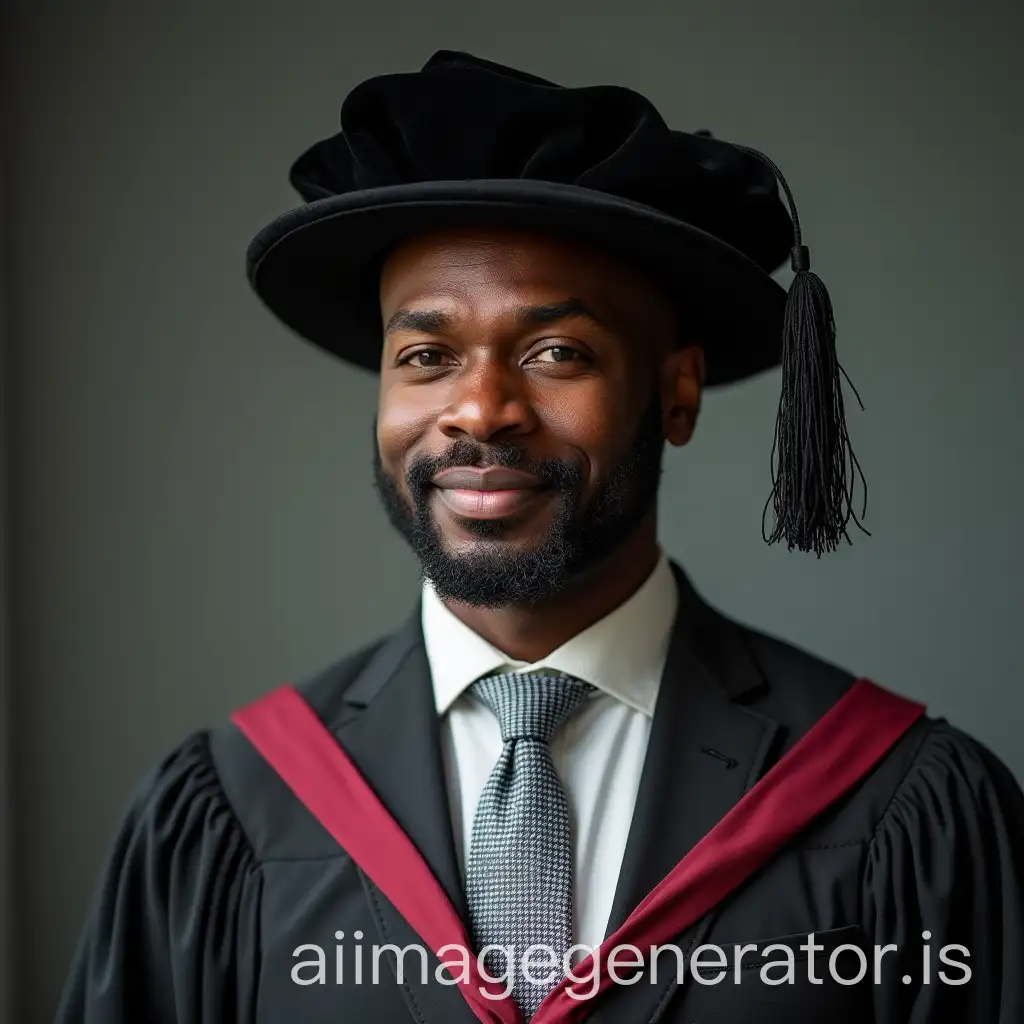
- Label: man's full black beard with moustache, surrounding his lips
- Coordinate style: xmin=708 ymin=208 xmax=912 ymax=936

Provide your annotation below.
xmin=374 ymin=389 xmax=665 ymax=608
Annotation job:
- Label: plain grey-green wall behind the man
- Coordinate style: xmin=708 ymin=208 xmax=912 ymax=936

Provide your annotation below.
xmin=2 ymin=0 xmax=1024 ymax=1024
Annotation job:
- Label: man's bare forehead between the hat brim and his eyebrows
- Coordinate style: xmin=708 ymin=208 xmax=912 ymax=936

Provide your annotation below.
xmin=380 ymin=227 xmax=667 ymax=314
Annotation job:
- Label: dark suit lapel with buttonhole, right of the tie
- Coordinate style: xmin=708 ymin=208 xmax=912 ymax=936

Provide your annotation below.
xmin=593 ymin=564 xmax=778 ymax=1024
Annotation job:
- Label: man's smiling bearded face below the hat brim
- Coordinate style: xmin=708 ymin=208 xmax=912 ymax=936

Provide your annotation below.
xmin=375 ymin=230 xmax=700 ymax=607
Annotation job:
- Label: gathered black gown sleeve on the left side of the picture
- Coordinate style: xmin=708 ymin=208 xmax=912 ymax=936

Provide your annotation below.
xmin=56 ymin=733 xmax=262 ymax=1024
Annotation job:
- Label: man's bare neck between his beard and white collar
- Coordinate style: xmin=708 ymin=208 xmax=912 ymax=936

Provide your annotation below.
xmin=444 ymin=517 xmax=659 ymax=663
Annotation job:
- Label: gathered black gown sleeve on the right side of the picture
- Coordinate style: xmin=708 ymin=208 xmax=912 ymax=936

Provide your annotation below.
xmin=863 ymin=722 xmax=1024 ymax=1024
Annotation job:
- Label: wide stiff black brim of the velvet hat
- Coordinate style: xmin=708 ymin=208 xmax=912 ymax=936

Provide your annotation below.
xmin=247 ymin=178 xmax=785 ymax=387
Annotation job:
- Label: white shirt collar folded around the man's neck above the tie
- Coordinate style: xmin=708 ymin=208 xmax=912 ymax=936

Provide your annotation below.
xmin=421 ymin=552 xmax=679 ymax=717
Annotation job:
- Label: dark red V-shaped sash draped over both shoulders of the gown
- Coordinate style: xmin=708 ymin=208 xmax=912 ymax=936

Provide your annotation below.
xmin=231 ymin=679 xmax=925 ymax=1024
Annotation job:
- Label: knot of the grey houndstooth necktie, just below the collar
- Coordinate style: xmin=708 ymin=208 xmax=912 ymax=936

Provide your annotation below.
xmin=470 ymin=672 xmax=594 ymax=743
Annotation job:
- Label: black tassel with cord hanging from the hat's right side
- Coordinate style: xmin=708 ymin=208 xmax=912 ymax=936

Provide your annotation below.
xmin=740 ymin=146 xmax=870 ymax=558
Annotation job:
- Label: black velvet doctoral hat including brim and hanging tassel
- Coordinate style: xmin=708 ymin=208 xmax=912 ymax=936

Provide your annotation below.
xmin=247 ymin=50 xmax=855 ymax=553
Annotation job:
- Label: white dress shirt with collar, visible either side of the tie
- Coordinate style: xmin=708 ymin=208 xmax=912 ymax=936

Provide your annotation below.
xmin=422 ymin=554 xmax=679 ymax=947
